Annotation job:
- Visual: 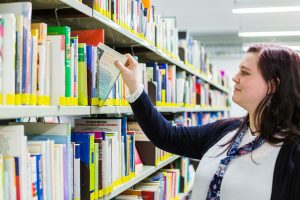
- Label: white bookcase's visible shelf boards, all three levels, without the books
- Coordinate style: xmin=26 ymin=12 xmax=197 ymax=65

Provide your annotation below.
xmin=0 ymin=0 xmax=229 ymax=199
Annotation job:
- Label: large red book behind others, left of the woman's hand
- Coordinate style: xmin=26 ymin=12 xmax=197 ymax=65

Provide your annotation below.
xmin=71 ymin=29 xmax=105 ymax=46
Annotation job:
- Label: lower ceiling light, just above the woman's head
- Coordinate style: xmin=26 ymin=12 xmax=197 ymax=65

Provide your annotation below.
xmin=238 ymin=31 xmax=300 ymax=37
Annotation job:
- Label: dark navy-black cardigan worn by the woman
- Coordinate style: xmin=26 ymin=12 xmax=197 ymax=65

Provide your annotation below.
xmin=131 ymin=91 xmax=300 ymax=200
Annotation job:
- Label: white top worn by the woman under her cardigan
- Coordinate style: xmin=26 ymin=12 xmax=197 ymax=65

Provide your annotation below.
xmin=192 ymin=129 xmax=281 ymax=200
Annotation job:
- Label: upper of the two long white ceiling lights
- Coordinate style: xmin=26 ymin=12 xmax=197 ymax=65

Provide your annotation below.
xmin=232 ymin=6 xmax=300 ymax=14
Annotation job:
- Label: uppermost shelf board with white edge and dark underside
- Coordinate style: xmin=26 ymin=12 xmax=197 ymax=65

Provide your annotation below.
xmin=25 ymin=0 xmax=229 ymax=94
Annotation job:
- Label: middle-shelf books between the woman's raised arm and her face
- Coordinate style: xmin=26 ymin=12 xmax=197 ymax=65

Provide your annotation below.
xmin=141 ymin=62 xmax=227 ymax=107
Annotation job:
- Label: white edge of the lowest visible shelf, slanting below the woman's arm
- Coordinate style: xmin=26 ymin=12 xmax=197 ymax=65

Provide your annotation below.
xmin=104 ymin=155 xmax=180 ymax=199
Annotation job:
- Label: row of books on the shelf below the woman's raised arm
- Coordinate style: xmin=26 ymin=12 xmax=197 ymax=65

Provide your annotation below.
xmin=0 ymin=117 xmax=171 ymax=200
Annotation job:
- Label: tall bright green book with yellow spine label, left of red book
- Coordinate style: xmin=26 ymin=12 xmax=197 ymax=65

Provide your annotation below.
xmin=47 ymin=26 xmax=72 ymax=105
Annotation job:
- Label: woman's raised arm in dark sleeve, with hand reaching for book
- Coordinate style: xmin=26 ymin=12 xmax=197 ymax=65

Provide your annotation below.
xmin=116 ymin=54 xmax=239 ymax=159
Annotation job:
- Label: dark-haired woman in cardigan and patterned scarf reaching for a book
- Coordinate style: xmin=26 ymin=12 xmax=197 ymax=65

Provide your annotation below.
xmin=116 ymin=44 xmax=300 ymax=200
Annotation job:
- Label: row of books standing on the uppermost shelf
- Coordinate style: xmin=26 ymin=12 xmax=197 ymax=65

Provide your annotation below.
xmin=79 ymin=0 xmax=228 ymax=85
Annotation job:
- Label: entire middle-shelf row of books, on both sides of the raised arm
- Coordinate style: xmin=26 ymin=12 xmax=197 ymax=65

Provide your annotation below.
xmin=0 ymin=2 xmax=227 ymax=107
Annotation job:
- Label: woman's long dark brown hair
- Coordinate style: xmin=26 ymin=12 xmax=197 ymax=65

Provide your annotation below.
xmin=224 ymin=44 xmax=300 ymax=146
